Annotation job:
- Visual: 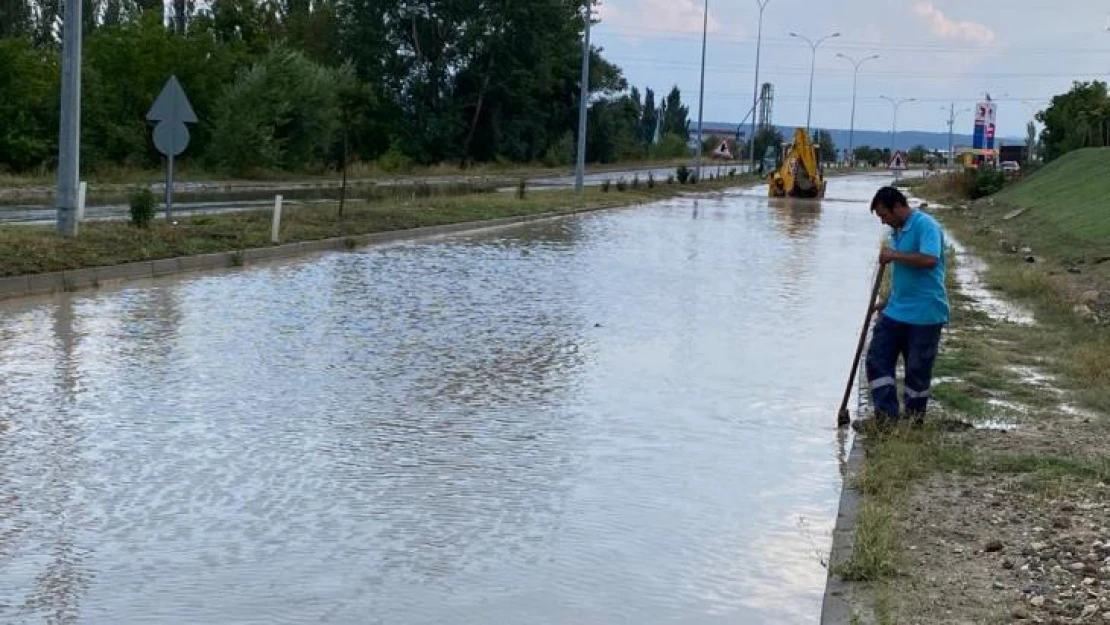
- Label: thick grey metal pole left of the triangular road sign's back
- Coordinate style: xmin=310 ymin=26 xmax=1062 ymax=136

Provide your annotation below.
xmin=57 ymin=0 xmax=81 ymax=236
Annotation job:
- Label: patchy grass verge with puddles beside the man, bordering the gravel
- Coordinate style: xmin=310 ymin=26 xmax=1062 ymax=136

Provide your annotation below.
xmin=833 ymin=215 xmax=1110 ymax=623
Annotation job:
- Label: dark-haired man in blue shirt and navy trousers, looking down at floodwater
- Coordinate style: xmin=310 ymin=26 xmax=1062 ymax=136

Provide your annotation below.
xmin=866 ymin=187 xmax=949 ymax=424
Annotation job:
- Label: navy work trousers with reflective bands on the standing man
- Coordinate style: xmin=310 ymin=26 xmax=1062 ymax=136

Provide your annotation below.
xmin=866 ymin=313 xmax=944 ymax=421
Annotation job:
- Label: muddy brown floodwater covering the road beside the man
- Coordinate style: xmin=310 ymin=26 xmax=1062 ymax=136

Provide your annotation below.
xmin=0 ymin=177 xmax=888 ymax=625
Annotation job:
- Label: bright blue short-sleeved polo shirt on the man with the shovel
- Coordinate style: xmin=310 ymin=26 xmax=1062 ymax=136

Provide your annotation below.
xmin=882 ymin=210 xmax=948 ymax=325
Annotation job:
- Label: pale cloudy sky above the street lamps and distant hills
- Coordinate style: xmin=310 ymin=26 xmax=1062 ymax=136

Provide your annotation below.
xmin=593 ymin=0 xmax=1110 ymax=137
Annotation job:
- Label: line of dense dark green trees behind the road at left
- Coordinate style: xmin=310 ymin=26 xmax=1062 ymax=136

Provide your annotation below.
xmin=0 ymin=0 xmax=689 ymax=174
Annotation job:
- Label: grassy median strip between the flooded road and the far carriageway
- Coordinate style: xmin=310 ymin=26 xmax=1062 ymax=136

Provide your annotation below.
xmin=0 ymin=177 xmax=750 ymax=276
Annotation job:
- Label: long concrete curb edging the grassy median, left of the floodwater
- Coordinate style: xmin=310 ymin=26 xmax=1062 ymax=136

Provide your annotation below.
xmin=0 ymin=204 xmax=617 ymax=300
